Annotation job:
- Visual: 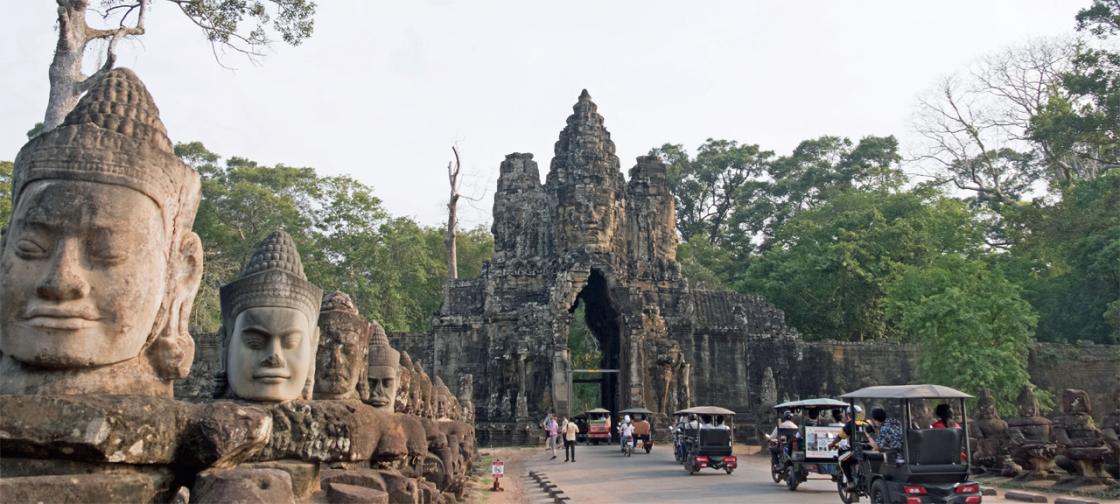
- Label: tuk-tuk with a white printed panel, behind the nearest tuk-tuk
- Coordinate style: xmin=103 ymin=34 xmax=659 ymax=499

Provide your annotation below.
xmin=769 ymin=398 xmax=848 ymax=492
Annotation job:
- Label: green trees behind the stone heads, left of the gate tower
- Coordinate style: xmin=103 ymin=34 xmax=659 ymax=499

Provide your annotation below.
xmin=176 ymin=142 xmax=494 ymax=332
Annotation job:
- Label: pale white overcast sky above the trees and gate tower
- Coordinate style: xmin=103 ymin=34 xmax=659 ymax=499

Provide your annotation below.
xmin=0 ymin=0 xmax=1089 ymax=226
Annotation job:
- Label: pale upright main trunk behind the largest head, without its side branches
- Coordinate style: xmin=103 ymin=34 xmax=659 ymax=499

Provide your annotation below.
xmin=43 ymin=0 xmax=90 ymax=131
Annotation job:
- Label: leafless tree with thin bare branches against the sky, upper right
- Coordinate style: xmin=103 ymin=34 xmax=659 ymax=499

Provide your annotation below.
xmin=915 ymin=40 xmax=1076 ymax=200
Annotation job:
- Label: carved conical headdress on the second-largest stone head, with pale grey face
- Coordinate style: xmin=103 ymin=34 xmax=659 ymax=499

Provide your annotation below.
xmin=221 ymin=231 xmax=323 ymax=320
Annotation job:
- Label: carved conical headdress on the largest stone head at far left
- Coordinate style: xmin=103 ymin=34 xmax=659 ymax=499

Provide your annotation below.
xmin=11 ymin=68 xmax=200 ymax=232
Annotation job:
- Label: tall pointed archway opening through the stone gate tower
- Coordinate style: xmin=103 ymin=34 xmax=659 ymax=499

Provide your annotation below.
xmin=568 ymin=269 xmax=623 ymax=413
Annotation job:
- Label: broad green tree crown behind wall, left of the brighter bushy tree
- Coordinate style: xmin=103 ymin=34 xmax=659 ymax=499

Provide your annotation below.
xmin=739 ymin=192 xmax=983 ymax=340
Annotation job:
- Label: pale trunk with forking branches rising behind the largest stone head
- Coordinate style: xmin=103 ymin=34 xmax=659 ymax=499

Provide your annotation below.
xmin=43 ymin=0 xmax=151 ymax=130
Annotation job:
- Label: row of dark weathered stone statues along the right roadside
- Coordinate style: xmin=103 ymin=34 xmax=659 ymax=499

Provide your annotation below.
xmin=970 ymin=384 xmax=1120 ymax=486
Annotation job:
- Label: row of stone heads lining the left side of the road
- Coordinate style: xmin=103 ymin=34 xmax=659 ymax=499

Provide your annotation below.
xmin=0 ymin=68 xmax=474 ymax=502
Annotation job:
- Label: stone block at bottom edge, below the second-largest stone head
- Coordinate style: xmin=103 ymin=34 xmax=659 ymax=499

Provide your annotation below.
xmin=190 ymin=468 xmax=296 ymax=504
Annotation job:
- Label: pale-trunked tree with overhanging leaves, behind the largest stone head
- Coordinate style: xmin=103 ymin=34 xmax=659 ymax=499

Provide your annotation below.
xmin=43 ymin=0 xmax=316 ymax=131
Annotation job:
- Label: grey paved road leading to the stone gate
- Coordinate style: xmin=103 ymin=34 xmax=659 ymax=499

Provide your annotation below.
xmin=524 ymin=445 xmax=1034 ymax=504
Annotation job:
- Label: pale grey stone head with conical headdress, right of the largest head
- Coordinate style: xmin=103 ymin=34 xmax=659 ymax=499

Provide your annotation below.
xmin=217 ymin=231 xmax=323 ymax=402
